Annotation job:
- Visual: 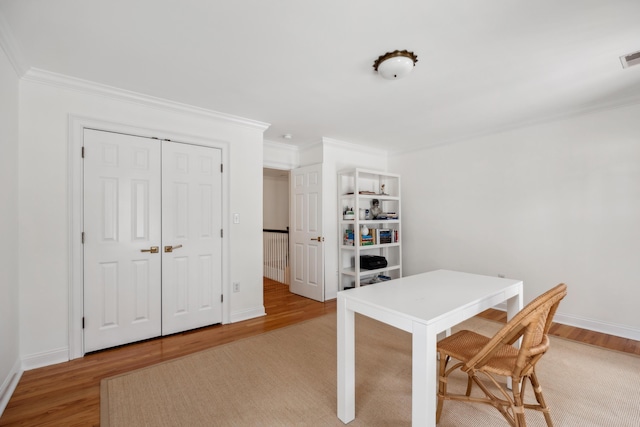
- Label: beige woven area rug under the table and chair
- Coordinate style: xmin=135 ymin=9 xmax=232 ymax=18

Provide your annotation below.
xmin=100 ymin=315 xmax=640 ymax=427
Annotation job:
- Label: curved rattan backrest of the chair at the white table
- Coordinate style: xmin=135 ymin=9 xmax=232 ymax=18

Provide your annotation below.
xmin=462 ymin=283 xmax=567 ymax=377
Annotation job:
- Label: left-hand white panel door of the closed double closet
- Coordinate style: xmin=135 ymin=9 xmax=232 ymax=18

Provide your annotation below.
xmin=84 ymin=130 xmax=161 ymax=352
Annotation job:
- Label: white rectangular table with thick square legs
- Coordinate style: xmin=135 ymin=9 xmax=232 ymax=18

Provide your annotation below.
xmin=337 ymin=270 xmax=522 ymax=426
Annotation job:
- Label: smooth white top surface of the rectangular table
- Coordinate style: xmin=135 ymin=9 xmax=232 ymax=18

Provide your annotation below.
xmin=338 ymin=270 xmax=522 ymax=323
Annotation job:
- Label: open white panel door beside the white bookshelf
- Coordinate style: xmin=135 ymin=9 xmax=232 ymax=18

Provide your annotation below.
xmin=289 ymin=164 xmax=324 ymax=301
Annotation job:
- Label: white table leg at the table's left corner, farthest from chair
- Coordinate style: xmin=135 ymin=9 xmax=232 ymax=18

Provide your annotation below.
xmin=337 ymin=295 xmax=356 ymax=424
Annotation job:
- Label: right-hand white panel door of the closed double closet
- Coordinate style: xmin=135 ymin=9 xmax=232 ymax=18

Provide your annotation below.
xmin=162 ymin=141 xmax=222 ymax=335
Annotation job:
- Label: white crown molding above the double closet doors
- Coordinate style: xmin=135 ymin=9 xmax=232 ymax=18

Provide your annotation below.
xmin=22 ymin=68 xmax=271 ymax=132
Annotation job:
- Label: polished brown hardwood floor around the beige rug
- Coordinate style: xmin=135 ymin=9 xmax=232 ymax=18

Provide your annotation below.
xmin=0 ymin=279 xmax=640 ymax=426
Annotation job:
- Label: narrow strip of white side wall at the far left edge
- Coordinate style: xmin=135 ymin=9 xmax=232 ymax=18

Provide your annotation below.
xmin=0 ymin=40 xmax=20 ymax=415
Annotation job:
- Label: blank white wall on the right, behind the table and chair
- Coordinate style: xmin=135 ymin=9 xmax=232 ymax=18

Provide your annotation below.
xmin=390 ymin=105 xmax=640 ymax=340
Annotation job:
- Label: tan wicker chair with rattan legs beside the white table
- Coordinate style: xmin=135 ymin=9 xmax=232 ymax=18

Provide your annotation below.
xmin=436 ymin=283 xmax=567 ymax=427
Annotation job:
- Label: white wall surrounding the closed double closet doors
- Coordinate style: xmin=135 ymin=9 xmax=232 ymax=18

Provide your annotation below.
xmin=18 ymin=73 xmax=264 ymax=366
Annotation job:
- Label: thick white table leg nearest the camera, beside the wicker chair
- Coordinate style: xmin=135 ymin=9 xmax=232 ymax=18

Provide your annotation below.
xmin=411 ymin=322 xmax=437 ymax=427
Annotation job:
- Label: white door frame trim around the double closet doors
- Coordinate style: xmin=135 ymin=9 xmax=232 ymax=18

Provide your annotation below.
xmin=67 ymin=114 xmax=231 ymax=360
